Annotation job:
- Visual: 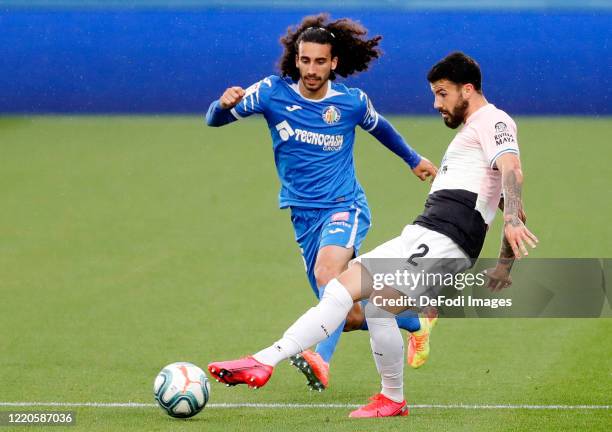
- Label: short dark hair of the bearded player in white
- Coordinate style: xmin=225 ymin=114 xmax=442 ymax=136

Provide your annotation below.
xmin=427 ymin=51 xmax=482 ymax=92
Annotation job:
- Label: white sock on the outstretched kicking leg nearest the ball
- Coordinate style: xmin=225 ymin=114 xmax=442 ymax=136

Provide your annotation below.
xmin=253 ymin=279 xmax=353 ymax=366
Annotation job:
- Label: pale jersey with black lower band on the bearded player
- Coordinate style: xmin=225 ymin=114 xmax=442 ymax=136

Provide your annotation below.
xmin=415 ymin=104 xmax=519 ymax=258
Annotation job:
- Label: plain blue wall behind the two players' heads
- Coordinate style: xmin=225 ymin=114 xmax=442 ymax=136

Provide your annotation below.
xmin=0 ymin=7 xmax=612 ymax=115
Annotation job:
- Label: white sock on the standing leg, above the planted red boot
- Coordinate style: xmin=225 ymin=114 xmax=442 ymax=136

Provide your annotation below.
xmin=366 ymin=303 xmax=404 ymax=402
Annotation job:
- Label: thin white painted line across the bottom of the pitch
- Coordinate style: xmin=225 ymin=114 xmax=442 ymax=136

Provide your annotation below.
xmin=0 ymin=402 xmax=612 ymax=410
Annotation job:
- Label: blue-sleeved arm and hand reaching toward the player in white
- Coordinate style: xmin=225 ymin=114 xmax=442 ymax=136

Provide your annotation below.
xmin=369 ymin=114 xmax=438 ymax=180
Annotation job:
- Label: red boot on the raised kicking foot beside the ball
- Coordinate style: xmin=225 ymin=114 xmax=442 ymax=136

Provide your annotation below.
xmin=208 ymin=356 xmax=274 ymax=389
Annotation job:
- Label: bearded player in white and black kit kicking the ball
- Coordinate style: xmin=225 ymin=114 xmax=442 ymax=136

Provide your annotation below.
xmin=208 ymin=52 xmax=538 ymax=418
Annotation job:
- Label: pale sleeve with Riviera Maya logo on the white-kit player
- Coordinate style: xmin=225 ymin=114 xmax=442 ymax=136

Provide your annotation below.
xmin=477 ymin=115 xmax=519 ymax=169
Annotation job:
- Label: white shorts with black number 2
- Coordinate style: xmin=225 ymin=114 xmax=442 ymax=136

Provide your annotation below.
xmin=351 ymin=225 xmax=472 ymax=296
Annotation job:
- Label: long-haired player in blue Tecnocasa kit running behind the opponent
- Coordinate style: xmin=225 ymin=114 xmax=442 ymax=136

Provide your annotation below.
xmin=206 ymin=14 xmax=437 ymax=391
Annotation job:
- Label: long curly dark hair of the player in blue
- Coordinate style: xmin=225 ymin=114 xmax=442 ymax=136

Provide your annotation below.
xmin=279 ymin=13 xmax=382 ymax=81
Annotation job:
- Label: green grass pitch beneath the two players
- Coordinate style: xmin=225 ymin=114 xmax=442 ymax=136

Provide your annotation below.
xmin=0 ymin=116 xmax=612 ymax=432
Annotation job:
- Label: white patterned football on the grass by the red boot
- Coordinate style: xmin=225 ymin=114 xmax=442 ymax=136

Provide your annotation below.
xmin=153 ymin=362 xmax=210 ymax=418
